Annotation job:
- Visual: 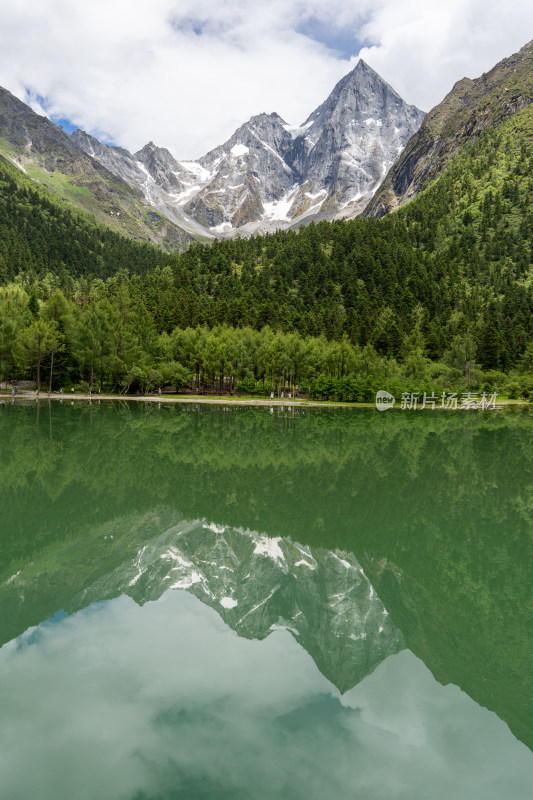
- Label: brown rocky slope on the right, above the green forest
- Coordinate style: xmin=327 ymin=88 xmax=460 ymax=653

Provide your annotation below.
xmin=364 ymin=41 xmax=533 ymax=217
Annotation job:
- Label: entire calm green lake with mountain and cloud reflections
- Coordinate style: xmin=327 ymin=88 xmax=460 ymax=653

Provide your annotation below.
xmin=0 ymin=401 xmax=533 ymax=800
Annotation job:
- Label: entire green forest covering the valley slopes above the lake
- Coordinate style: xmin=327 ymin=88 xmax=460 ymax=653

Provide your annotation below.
xmin=0 ymin=106 xmax=533 ymax=400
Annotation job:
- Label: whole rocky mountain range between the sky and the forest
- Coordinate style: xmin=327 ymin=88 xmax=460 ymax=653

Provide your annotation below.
xmin=0 ymin=42 xmax=533 ymax=245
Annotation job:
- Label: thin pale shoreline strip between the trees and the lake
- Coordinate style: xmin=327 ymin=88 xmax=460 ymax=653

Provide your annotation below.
xmin=0 ymin=390 xmax=530 ymax=413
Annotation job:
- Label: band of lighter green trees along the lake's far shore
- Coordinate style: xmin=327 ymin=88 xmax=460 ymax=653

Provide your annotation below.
xmin=0 ymin=278 xmax=533 ymax=401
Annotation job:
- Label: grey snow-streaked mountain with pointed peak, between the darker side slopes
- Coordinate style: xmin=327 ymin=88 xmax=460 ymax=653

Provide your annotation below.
xmin=72 ymin=61 xmax=424 ymax=236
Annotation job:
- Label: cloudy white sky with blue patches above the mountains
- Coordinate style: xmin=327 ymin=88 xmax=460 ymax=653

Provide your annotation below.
xmin=0 ymin=0 xmax=533 ymax=159
